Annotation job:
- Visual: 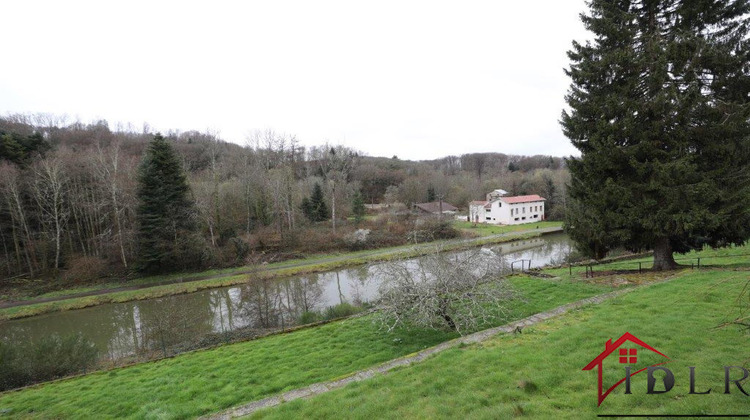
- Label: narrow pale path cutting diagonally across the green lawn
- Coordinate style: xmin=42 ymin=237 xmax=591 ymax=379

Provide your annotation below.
xmin=203 ymin=276 xmax=648 ymax=420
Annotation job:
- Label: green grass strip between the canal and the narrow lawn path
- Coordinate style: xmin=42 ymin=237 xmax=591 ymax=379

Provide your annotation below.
xmin=0 ymin=277 xmax=624 ymax=418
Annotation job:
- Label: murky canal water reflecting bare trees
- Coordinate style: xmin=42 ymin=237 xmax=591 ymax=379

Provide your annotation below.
xmin=0 ymin=233 xmax=573 ymax=362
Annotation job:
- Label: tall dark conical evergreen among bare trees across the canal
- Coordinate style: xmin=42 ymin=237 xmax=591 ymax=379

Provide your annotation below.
xmin=137 ymin=134 xmax=199 ymax=272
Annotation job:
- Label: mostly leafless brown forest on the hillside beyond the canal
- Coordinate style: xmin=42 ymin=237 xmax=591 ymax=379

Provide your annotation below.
xmin=0 ymin=114 xmax=569 ymax=283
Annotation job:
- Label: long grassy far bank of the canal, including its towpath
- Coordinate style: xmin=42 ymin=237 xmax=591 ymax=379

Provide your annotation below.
xmin=0 ymin=222 xmax=562 ymax=320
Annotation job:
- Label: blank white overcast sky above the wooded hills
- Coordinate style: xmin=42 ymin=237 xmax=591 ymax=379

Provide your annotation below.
xmin=0 ymin=0 xmax=587 ymax=159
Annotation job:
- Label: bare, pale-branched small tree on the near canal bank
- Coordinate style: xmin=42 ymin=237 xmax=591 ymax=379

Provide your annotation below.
xmin=378 ymin=249 xmax=513 ymax=334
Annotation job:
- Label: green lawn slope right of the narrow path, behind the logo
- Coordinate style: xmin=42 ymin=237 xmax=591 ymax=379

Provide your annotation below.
xmin=256 ymin=270 xmax=750 ymax=419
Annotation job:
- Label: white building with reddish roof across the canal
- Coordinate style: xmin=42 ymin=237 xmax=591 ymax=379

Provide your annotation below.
xmin=469 ymin=190 xmax=545 ymax=225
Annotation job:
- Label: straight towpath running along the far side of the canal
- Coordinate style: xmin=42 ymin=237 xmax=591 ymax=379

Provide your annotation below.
xmin=0 ymin=227 xmax=563 ymax=309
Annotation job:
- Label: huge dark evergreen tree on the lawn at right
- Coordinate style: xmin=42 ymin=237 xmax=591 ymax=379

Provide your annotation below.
xmin=562 ymin=0 xmax=750 ymax=270
